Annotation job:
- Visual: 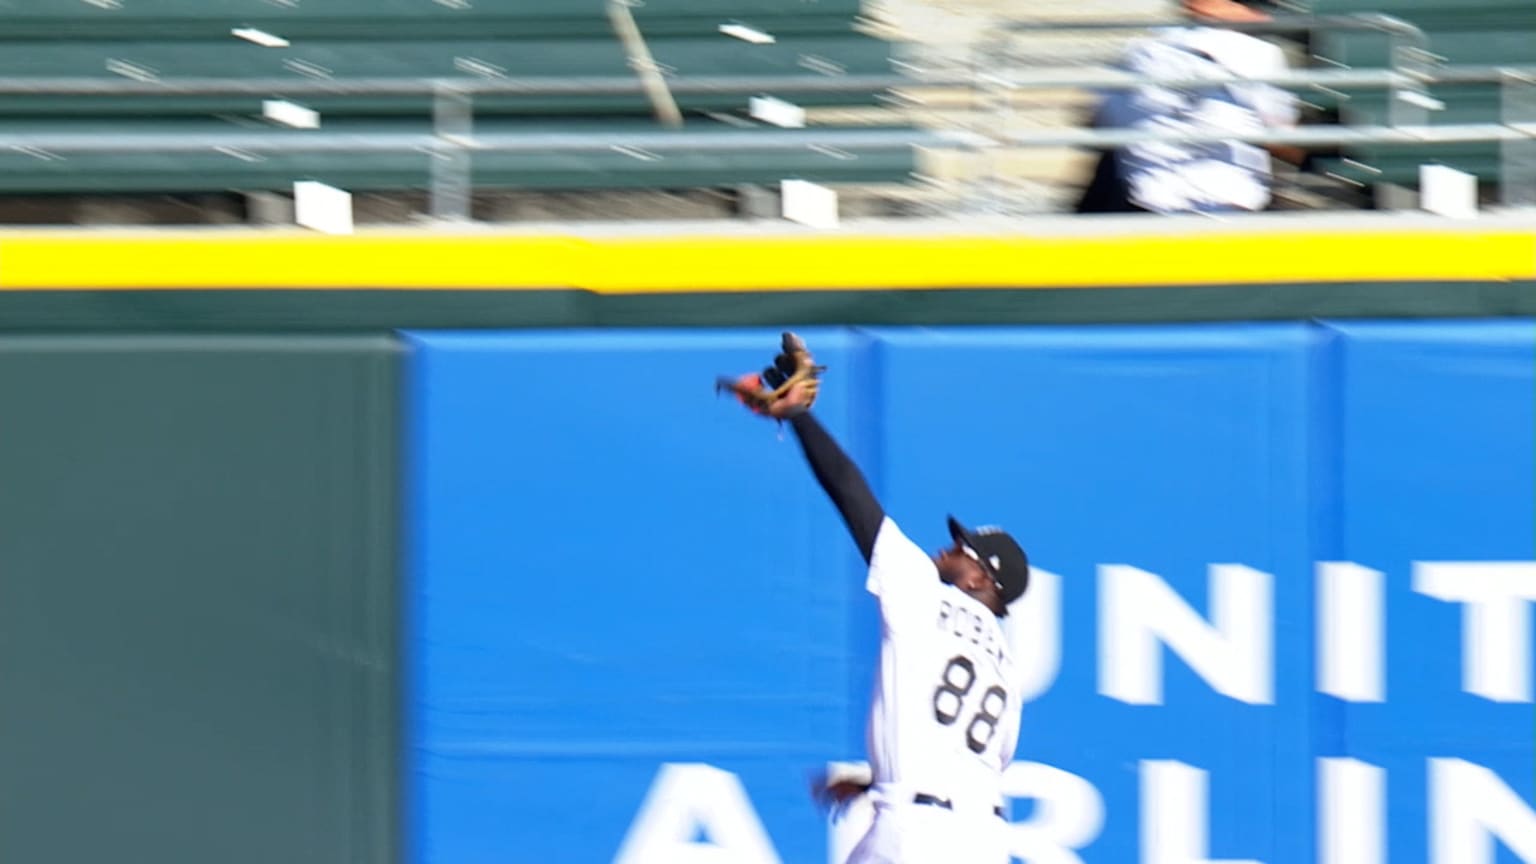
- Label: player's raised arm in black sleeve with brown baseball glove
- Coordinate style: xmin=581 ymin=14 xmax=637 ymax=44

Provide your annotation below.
xmin=720 ymin=327 xmax=885 ymax=561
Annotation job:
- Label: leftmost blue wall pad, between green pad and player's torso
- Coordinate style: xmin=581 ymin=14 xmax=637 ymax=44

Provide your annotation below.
xmin=409 ymin=331 xmax=868 ymax=864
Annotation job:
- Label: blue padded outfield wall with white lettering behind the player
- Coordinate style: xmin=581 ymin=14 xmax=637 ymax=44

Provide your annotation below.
xmin=406 ymin=321 xmax=1536 ymax=864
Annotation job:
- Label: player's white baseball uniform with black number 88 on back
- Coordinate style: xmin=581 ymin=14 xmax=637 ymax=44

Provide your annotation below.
xmin=848 ymin=517 xmax=1021 ymax=864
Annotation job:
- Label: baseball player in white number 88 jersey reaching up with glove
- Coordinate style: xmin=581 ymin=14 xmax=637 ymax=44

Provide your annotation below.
xmin=725 ymin=334 xmax=1029 ymax=864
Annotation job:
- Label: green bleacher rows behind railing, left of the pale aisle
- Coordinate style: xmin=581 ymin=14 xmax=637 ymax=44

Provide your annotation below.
xmin=0 ymin=0 xmax=914 ymax=192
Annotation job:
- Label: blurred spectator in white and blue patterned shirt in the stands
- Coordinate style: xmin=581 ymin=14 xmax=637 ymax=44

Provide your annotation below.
xmin=1077 ymin=0 xmax=1304 ymax=214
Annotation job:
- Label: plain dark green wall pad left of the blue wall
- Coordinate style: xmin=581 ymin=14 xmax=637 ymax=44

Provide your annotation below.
xmin=0 ymin=335 xmax=398 ymax=864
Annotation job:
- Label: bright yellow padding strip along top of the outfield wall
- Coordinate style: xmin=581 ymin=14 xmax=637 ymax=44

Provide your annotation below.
xmin=0 ymin=228 xmax=1536 ymax=294
